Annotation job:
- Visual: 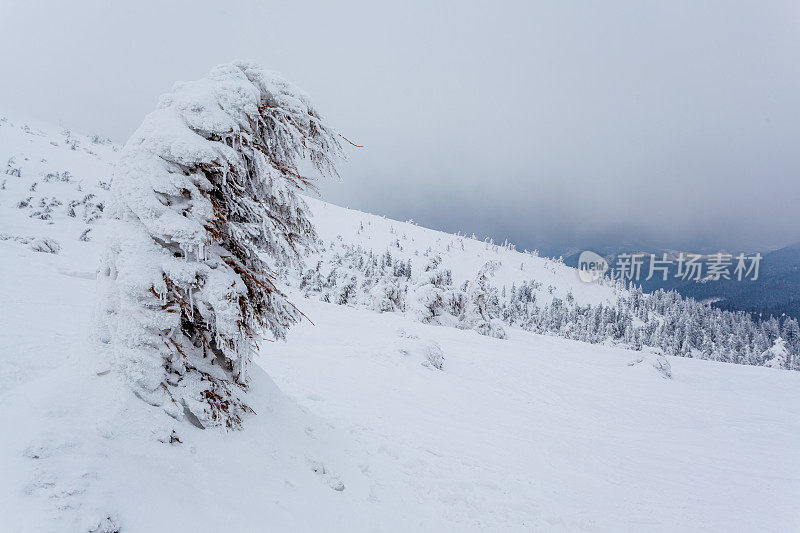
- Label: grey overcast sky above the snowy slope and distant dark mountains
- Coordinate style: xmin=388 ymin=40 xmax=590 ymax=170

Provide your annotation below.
xmin=0 ymin=0 xmax=800 ymax=253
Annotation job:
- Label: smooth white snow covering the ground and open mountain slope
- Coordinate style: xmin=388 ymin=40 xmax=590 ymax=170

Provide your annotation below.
xmin=0 ymin=114 xmax=800 ymax=532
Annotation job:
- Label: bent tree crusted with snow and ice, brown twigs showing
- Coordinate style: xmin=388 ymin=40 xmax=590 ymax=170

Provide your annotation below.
xmin=98 ymin=62 xmax=342 ymax=428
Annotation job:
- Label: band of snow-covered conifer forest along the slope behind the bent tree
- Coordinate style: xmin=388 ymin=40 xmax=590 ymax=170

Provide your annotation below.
xmin=284 ymin=229 xmax=800 ymax=370
